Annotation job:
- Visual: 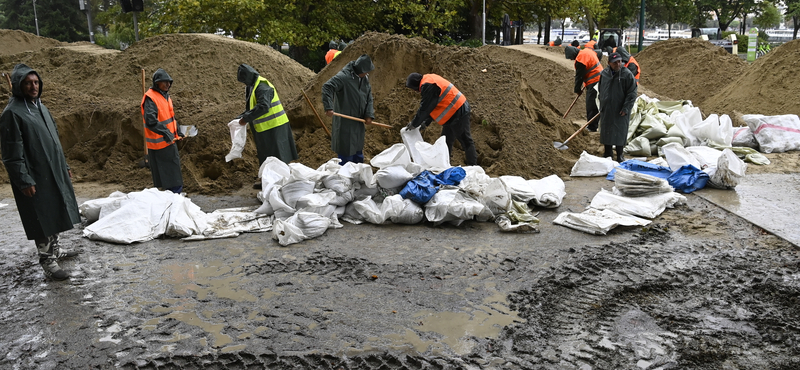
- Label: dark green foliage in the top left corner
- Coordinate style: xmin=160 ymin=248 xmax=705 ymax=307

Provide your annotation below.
xmin=0 ymin=0 xmax=89 ymax=42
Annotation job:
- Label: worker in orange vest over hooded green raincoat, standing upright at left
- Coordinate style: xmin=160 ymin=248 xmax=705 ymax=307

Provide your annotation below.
xmin=141 ymin=68 xmax=184 ymax=194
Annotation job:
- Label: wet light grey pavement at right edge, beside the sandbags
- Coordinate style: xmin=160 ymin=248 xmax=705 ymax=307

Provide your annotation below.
xmin=696 ymin=174 xmax=800 ymax=245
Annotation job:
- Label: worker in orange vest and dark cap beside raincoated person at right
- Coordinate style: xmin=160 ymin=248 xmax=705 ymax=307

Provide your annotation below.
xmin=564 ymin=46 xmax=603 ymax=132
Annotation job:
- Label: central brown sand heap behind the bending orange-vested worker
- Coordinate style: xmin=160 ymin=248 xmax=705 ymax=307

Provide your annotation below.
xmin=288 ymin=33 xmax=586 ymax=183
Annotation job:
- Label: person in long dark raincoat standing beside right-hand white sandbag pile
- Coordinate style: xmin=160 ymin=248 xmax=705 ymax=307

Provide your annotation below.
xmin=599 ymin=53 xmax=637 ymax=163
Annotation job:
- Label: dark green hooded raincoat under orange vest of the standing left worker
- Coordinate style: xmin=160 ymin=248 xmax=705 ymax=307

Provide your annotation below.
xmin=143 ymin=68 xmax=183 ymax=189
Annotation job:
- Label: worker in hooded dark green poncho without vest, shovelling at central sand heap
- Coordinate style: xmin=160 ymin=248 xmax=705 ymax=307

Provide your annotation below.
xmin=322 ymin=54 xmax=375 ymax=164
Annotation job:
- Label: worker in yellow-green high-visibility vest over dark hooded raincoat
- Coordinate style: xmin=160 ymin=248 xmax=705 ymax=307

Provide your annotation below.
xmin=236 ymin=64 xmax=298 ymax=168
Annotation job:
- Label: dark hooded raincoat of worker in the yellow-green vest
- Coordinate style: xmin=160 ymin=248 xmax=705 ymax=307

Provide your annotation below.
xmin=236 ymin=64 xmax=299 ymax=165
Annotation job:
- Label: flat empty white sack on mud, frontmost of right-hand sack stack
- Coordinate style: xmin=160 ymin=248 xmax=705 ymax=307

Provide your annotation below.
xmin=553 ymin=208 xmax=651 ymax=235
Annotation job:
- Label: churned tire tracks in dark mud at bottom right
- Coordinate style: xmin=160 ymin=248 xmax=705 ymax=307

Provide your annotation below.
xmin=494 ymin=226 xmax=800 ymax=369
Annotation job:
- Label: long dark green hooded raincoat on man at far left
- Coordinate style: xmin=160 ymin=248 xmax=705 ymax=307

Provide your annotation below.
xmin=0 ymin=64 xmax=81 ymax=240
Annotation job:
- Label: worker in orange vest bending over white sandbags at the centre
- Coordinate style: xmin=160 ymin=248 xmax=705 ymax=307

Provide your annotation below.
xmin=406 ymin=73 xmax=478 ymax=166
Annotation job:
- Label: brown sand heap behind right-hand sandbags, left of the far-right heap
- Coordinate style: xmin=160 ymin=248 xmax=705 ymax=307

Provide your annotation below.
xmin=634 ymin=39 xmax=748 ymax=105
